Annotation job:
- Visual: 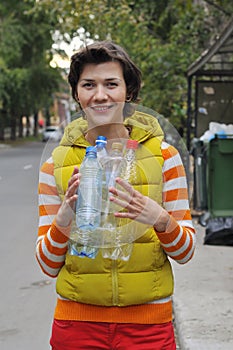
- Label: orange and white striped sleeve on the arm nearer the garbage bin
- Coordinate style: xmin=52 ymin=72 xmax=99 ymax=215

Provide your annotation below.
xmin=157 ymin=142 xmax=196 ymax=264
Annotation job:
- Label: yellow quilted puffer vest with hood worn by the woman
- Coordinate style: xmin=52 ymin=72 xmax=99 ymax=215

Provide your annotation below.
xmin=53 ymin=112 xmax=173 ymax=306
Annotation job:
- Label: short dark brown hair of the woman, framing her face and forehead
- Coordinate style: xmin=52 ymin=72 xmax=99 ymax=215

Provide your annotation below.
xmin=68 ymin=41 xmax=141 ymax=102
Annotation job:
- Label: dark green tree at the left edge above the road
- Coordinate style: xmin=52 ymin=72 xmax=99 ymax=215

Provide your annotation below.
xmin=0 ymin=0 xmax=60 ymax=139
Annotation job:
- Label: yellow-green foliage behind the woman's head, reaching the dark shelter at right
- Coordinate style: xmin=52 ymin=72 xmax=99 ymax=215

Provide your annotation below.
xmin=31 ymin=0 xmax=233 ymax=128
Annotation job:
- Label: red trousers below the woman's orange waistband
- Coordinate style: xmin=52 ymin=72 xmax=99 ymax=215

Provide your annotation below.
xmin=50 ymin=320 xmax=176 ymax=350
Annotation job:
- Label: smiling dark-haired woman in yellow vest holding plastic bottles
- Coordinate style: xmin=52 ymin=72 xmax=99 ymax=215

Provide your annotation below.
xmin=36 ymin=41 xmax=195 ymax=350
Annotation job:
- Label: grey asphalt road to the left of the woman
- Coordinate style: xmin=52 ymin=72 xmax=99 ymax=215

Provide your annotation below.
xmin=0 ymin=142 xmax=56 ymax=350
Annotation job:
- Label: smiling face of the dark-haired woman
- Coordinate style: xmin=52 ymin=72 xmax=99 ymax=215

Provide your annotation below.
xmin=77 ymin=62 xmax=126 ymax=127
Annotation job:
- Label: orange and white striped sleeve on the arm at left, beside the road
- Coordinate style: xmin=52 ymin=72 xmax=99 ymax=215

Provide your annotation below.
xmin=36 ymin=157 xmax=68 ymax=277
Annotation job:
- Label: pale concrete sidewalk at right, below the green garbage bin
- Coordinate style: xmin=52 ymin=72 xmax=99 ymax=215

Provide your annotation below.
xmin=172 ymin=220 xmax=233 ymax=350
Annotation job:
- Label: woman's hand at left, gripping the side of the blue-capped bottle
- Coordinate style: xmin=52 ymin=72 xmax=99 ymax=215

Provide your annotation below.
xmin=56 ymin=167 xmax=80 ymax=227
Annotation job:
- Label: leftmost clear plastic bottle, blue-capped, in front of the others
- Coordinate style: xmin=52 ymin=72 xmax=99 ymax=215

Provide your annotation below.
xmin=73 ymin=146 xmax=102 ymax=258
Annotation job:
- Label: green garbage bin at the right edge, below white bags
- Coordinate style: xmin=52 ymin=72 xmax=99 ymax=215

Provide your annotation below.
xmin=207 ymin=136 xmax=233 ymax=217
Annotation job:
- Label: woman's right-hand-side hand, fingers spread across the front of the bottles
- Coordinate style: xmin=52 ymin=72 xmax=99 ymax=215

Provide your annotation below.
xmin=109 ymin=178 xmax=170 ymax=232
